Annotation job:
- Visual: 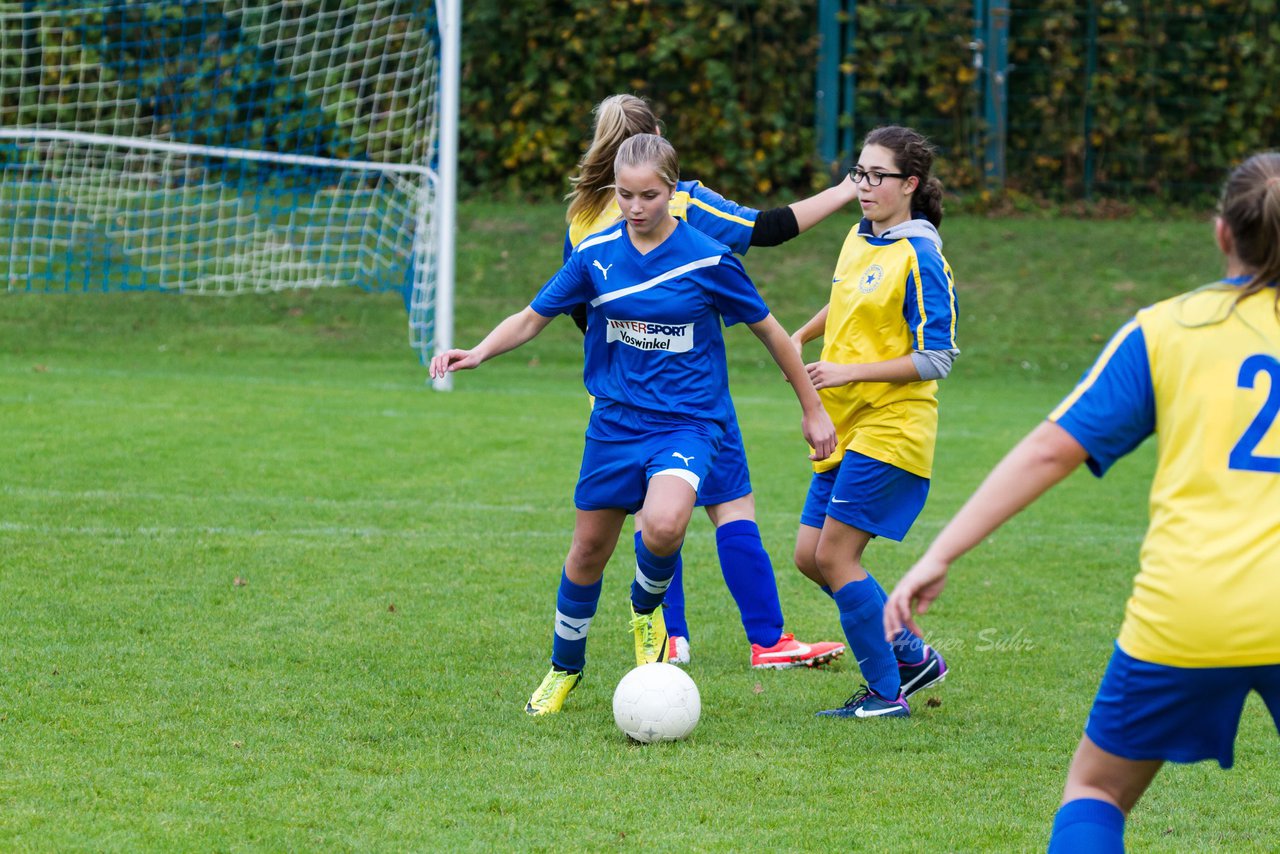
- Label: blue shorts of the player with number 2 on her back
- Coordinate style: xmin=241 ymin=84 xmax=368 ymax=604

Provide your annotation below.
xmin=1084 ymin=644 xmax=1280 ymax=768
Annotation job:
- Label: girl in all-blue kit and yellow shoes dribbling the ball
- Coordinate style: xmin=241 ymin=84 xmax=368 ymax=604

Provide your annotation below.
xmin=431 ymin=134 xmax=835 ymax=714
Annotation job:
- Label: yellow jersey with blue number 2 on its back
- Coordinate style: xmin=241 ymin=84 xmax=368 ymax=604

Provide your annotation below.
xmin=1050 ymin=280 xmax=1280 ymax=667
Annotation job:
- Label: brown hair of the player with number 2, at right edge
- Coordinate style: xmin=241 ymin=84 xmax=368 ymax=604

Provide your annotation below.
xmin=1219 ymin=151 xmax=1280 ymax=311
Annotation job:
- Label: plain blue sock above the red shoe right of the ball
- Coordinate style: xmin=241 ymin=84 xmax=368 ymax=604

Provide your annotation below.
xmin=711 ymin=519 xmax=782 ymax=647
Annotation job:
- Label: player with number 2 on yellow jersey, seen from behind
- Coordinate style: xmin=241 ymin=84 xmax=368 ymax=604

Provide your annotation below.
xmin=884 ymin=152 xmax=1280 ymax=851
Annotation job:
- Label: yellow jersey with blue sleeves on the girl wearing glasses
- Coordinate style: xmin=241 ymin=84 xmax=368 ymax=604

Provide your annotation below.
xmin=814 ymin=219 xmax=956 ymax=478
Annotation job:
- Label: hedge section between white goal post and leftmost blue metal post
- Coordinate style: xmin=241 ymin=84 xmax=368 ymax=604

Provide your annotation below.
xmin=460 ymin=0 xmax=826 ymax=198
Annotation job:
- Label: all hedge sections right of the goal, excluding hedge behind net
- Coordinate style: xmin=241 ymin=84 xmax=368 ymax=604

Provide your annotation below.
xmin=462 ymin=0 xmax=1280 ymax=201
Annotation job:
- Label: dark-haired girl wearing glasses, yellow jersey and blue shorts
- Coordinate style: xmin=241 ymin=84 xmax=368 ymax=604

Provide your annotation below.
xmin=792 ymin=127 xmax=959 ymax=718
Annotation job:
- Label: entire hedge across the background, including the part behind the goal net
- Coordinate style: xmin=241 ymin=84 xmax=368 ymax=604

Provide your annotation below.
xmin=0 ymin=0 xmax=1280 ymax=202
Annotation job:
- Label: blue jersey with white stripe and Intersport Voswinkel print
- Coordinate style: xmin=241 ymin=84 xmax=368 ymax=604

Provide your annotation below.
xmin=530 ymin=220 xmax=769 ymax=429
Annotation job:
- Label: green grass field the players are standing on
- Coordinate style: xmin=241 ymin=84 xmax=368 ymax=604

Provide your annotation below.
xmin=0 ymin=204 xmax=1280 ymax=851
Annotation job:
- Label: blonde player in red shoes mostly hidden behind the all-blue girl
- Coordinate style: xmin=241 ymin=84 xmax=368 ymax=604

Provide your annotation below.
xmin=564 ymin=95 xmax=856 ymax=668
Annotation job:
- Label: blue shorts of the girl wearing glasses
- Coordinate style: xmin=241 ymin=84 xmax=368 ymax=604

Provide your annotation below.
xmin=800 ymin=451 xmax=929 ymax=540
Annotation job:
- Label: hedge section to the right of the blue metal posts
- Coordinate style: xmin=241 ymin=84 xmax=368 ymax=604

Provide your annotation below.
xmin=1009 ymin=0 xmax=1280 ymax=200
